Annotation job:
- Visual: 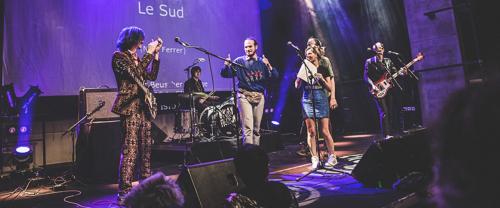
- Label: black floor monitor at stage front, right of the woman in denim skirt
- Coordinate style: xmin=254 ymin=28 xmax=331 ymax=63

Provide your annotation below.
xmin=352 ymin=129 xmax=432 ymax=188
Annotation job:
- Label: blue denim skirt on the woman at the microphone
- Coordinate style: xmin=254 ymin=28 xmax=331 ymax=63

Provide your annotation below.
xmin=302 ymin=89 xmax=330 ymax=118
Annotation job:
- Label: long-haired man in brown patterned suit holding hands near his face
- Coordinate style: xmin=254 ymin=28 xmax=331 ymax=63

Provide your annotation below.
xmin=112 ymin=26 xmax=163 ymax=203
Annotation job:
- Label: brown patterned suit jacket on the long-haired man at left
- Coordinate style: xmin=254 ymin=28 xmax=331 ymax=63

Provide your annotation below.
xmin=111 ymin=51 xmax=160 ymax=116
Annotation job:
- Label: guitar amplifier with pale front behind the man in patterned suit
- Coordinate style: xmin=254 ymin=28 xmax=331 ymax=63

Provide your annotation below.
xmin=78 ymin=88 xmax=120 ymax=121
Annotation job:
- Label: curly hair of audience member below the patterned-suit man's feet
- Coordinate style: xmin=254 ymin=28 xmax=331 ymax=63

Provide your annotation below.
xmin=123 ymin=172 xmax=184 ymax=208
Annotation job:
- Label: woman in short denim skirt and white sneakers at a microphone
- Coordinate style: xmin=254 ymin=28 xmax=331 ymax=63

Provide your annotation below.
xmin=295 ymin=46 xmax=337 ymax=169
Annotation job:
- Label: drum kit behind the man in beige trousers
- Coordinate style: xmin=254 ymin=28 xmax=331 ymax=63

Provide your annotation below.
xmin=174 ymin=92 xmax=236 ymax=141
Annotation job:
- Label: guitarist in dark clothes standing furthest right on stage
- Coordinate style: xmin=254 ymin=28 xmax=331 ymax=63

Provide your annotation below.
xmin=364 ymin=42 xmax=397 ymax=139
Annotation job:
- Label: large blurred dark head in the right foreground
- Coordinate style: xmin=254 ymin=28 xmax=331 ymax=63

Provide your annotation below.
xmin=432 ymin=82 xmax=500 ymax=208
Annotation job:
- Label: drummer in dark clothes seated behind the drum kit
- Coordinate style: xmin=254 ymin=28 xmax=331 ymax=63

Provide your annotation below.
xmin=184 ymin=66 xmax=219 ymax=110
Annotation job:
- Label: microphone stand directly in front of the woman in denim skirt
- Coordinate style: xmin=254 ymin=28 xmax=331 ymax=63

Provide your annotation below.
xmin=295 ymin=48 xmax=330 ymax=181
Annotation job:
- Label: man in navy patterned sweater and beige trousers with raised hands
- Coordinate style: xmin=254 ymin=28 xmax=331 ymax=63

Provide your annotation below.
xmin=221 ymin=37 xmax=278 ymax=145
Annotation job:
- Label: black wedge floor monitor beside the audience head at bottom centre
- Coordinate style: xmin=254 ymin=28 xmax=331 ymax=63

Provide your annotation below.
xmin=177 ymin=159 xmax=243 ymax=207
